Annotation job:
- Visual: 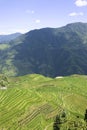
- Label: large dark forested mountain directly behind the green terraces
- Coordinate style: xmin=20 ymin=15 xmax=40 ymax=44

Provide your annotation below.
xmin=0 ymin=22 xmax=87 ymax=77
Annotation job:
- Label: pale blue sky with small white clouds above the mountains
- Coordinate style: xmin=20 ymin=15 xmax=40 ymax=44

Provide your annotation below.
xmin=0 ymin=0 xmax=87 ymax=35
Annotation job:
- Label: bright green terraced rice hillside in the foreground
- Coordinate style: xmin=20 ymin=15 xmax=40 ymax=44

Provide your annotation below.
xmin=0 ymin=74 xmax=87 ymax=130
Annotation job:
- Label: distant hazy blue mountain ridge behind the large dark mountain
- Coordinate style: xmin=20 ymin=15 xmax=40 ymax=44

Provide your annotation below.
xmin=0 ymin=33 xmax=21 ymax=43
